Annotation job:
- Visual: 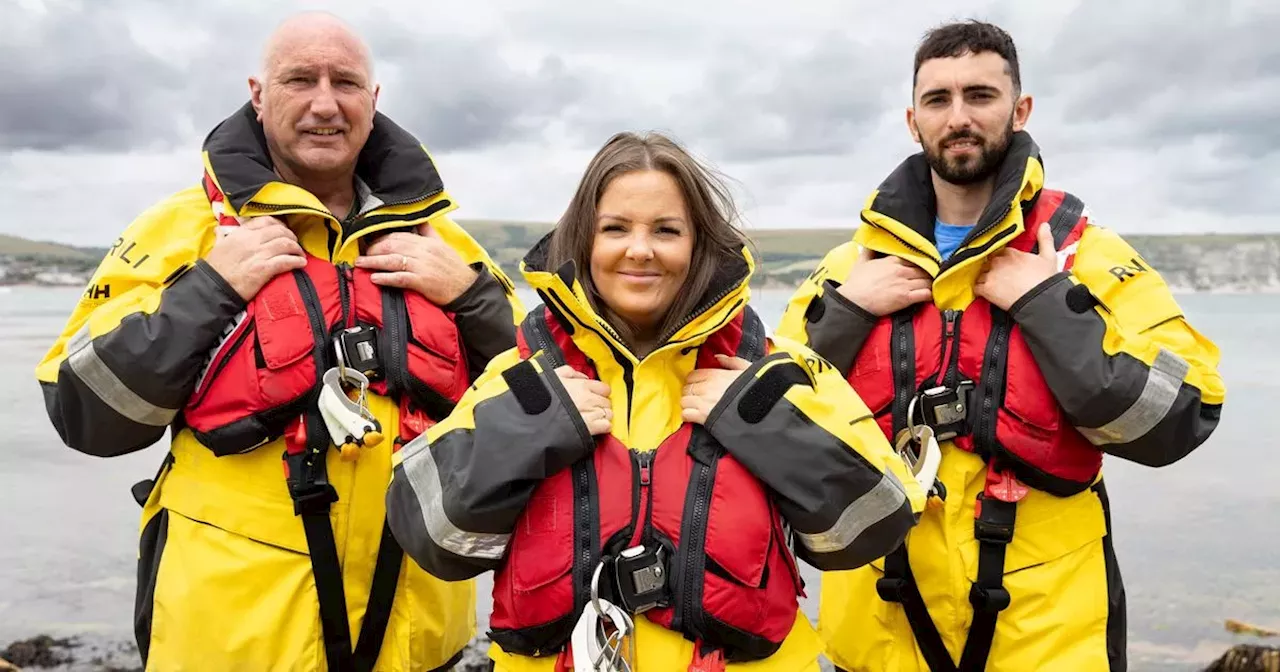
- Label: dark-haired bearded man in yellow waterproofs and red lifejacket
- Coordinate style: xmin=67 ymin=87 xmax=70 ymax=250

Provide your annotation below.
xmin=780 ymin=22 xmax=1225 ymax=672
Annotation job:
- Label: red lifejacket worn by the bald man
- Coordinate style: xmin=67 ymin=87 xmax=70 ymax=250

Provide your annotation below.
xmin=174 ymin=255 xmax=470 ymax=456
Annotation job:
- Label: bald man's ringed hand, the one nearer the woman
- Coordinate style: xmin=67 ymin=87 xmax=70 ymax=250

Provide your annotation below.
xmin=356 ymin=225 xmax=476 ymax=306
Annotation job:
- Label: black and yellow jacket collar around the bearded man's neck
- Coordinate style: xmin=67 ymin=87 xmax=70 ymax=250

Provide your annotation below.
xmin=854 ymin=131 xmax=1044 ymax=275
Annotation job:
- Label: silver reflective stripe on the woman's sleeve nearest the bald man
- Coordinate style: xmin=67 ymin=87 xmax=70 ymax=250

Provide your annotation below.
xmin=401 ymin=434 xmax=511 ymax=559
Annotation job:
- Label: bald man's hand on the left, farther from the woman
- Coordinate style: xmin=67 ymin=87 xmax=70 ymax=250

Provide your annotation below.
xmin=205 ymin=216 xmax=307 ymax=301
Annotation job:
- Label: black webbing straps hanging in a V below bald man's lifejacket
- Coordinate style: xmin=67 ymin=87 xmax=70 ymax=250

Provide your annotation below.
xmin=284 ymin=412 xmax=403 ymax=672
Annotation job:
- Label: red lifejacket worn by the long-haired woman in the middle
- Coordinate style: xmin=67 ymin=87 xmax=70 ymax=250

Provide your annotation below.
xmin=489 ymin=303 xmax=804 ymax=660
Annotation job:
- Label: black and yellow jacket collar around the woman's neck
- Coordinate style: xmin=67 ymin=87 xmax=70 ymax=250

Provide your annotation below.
xmin=520 ymin=230 xmax=755 ymax=361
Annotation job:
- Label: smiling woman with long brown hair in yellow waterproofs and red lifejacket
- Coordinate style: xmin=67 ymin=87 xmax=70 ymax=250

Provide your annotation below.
xmin=388 ymin=133 xmax=924 ymax=672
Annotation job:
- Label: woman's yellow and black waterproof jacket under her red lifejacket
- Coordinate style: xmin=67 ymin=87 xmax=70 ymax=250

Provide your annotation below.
xmin=388 ymin=237 xmax=924 ymax=672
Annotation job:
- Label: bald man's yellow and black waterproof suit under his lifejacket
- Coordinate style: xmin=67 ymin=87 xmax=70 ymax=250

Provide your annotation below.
xmin=36 ymin=105 xmax=522 ymax=672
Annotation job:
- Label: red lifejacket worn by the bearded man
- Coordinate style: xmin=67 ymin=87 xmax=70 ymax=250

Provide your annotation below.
xmin=849 ymin=189 xmax=1102 ymax=497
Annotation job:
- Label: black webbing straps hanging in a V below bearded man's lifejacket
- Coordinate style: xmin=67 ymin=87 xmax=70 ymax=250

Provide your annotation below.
xmin=876 ymin=495 xmax=1016 ymax=672
